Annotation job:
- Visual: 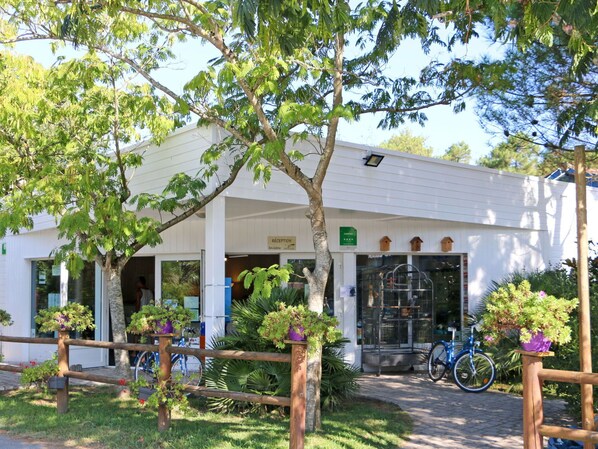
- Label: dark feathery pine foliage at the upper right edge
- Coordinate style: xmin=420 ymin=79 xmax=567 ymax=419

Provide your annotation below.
xmin=477 ymin=37 xmax=598 ymax=150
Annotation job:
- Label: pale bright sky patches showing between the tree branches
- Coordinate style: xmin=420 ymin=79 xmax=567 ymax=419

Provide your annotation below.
xmin=15 ymin=22 xmax=502 ymax=163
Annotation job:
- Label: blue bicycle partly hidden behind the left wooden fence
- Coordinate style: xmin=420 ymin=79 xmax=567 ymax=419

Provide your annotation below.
xmin=134 ymin=328 xmax=203 ymax=385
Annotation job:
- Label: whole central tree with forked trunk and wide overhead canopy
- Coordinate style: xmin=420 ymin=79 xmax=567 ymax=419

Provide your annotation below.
xmin=0 ymin=0 xmax=484 ymax=430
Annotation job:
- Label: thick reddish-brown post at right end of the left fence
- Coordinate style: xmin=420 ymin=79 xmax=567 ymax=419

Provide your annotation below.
xmin=285 ymin=341 xmax=307 ymax=449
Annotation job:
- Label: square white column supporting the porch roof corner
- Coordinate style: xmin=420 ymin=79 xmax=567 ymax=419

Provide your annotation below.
xmin=202 ymin=197 xmax=226 ymax=345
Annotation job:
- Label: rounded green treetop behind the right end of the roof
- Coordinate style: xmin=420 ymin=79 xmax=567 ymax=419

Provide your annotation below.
xmin=478 ymin=134 xmax=542 ymax=176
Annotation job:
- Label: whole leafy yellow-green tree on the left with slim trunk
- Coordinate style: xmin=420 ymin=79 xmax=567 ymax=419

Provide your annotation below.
xmin=0 ymin=53 xmax=248 ymax=377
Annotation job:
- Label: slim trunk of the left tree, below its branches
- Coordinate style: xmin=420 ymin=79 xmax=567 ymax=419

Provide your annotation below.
xmin=105 ymin=264 xmax=131 ymax=379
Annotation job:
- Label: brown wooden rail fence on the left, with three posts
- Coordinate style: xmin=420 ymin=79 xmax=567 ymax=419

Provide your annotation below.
xmin=0 ymin=332 xmax=307 ymax=449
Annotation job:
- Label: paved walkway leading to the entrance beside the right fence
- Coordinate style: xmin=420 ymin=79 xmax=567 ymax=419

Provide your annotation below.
xmin=360 ymin=374 xmax=576 ymax=449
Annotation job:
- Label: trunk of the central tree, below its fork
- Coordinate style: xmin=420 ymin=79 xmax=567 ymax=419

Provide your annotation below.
xmin=304 ymin=191 xmax=332 ymax=432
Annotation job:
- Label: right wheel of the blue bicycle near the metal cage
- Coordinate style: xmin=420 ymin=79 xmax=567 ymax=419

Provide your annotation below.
xmin=453 ymin=352 xmax=496 ymax=393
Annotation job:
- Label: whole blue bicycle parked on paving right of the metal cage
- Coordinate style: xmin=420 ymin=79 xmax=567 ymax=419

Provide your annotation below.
xmin=428 ymin=320 xmax=496 ymax=393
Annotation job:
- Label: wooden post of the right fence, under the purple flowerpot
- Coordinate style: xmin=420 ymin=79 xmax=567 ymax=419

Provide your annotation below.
xmin=517 ymin=350 xmax=554 ymax=449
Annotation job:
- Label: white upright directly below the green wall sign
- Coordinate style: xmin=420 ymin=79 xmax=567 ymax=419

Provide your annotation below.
xmin=342 ymin=253 xmax=361 ymax=367
